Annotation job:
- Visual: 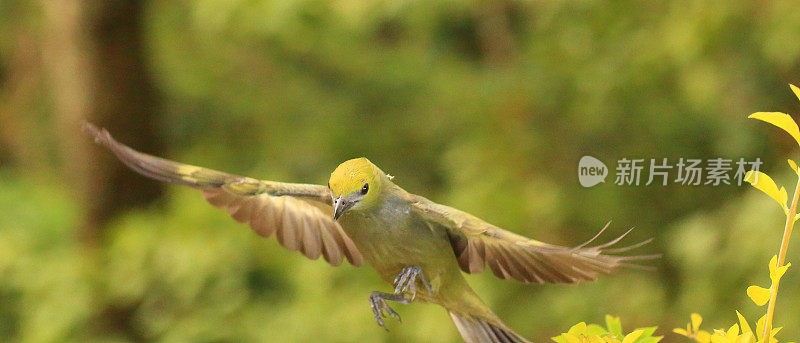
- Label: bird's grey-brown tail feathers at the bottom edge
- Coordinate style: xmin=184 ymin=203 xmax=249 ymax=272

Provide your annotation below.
xmin=450 ymin=312 xmax=530 ymax=343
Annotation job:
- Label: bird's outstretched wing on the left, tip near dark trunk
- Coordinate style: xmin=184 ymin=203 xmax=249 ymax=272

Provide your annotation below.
xmin=83 ymin=123 xmax=363 ymax=266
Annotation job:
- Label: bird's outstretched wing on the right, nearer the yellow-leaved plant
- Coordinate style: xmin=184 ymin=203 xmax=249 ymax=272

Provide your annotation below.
xmin=412 ymin=196 xmax=659 ymax=283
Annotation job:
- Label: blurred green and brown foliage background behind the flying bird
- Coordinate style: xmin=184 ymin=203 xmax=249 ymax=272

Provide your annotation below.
xmin=0 ymin=0 xmax=800 ymax=342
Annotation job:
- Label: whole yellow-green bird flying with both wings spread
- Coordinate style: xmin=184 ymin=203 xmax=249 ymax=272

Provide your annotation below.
xmin=84 ymin=123 xmax=657 ymax=343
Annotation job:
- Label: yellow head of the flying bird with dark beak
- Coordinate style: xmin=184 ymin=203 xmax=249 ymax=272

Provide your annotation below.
xmin=328 ymin=157 xmax=384 ymax=219
